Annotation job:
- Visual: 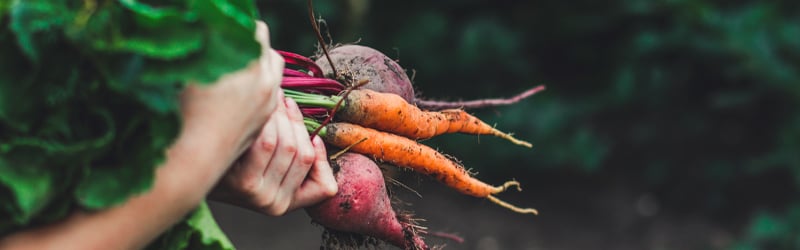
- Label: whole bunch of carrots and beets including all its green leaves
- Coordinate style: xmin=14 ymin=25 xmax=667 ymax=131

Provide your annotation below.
xmin=0 ymin=0 xmax=538 ymax=249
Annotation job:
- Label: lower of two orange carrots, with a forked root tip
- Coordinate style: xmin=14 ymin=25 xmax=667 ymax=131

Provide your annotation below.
xmin=306 ymin=120 xmax=538 ymax=214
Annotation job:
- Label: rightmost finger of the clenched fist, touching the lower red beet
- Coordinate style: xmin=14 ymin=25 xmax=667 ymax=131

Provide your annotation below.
xmin=290 ymin=136 xmax=338 ymax=210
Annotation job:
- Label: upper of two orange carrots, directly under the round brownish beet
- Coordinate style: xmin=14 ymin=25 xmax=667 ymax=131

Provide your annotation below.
xmin=336 ymin=89 xmax=531 ymax=147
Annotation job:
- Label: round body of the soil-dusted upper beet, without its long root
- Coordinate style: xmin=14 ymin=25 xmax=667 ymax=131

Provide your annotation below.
xmin=316 ymin=45 xmax=414 ymax=103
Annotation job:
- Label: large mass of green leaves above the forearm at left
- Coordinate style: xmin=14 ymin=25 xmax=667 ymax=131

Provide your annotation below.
xmin=0 ymin=0 xmax=260 ymax=246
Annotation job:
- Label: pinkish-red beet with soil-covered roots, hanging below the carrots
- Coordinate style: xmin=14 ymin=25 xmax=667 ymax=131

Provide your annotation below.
xmin=306 ymin=153 xmax=428 ymax=249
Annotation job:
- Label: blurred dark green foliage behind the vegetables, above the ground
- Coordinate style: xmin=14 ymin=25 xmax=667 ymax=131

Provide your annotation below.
xmin=253 ymin=0 xmax=800 ymax=249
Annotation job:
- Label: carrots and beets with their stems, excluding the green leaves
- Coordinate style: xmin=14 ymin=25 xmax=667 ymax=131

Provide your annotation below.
xmin=280 ymin=45 xmax=543 ymax=249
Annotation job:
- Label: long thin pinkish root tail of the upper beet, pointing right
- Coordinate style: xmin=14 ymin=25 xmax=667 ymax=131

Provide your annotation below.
xmin=414 ymin=85 xmax=545 ymax=110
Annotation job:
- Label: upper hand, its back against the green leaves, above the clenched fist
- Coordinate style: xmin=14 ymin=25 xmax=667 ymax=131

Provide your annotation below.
xmin=181 ymin=21 xmax=284 ymax=168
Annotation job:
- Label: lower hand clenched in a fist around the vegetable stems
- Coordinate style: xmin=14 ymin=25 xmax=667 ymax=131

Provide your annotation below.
xmin=211 ymin=96 xmax=337 ymax=216
